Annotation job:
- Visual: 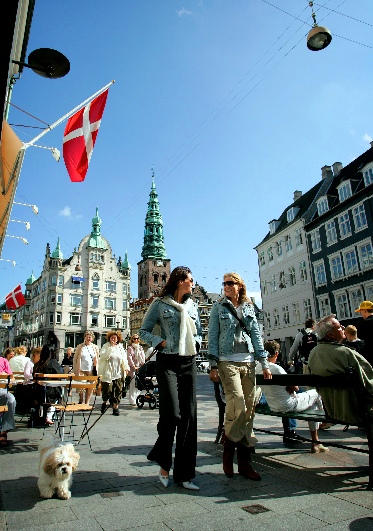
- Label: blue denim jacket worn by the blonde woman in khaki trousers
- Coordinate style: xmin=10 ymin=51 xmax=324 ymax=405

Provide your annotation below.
xmin=207 ymin=297 xmax=268 ymax=369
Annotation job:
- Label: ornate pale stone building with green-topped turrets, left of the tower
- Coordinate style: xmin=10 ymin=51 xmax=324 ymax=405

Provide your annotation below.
xmin=13 ymin=209 xmax=131 ymax=354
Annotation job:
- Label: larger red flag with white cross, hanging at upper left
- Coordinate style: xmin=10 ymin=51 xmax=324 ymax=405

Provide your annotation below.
xmin=63 ymin=89 xmax=109 ymax=182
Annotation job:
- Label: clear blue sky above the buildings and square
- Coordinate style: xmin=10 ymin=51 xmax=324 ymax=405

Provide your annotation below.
xmin=0 ymin=0 xmax=373 ymax=306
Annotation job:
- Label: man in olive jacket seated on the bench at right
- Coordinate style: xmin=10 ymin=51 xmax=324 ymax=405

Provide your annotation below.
xmin=308 ymin=314 xmax=373 ymax=425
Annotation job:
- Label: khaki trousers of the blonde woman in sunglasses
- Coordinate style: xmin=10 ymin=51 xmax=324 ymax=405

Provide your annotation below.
xmin=218 ymin=361 xmax=257 ymax=446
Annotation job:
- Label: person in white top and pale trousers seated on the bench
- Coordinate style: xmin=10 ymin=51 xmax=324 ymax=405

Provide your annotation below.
xmin=254 ymin=341 xmax=329 ymax=453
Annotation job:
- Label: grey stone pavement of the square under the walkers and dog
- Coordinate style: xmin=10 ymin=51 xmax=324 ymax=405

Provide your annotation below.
xmin=0 ymin=374 xmax=373 ymax=531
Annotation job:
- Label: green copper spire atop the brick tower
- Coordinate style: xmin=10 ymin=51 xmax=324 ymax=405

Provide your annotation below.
xmin=141 ymin=172 xmax=167 ymax=260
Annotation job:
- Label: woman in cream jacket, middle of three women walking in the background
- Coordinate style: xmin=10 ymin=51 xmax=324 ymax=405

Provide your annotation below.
xmin=97 ymin=330 xmax=129 ymax=417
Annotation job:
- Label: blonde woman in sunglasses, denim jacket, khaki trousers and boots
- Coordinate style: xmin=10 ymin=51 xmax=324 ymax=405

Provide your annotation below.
xmin=208 ymin=273 xmax=272 ymax=481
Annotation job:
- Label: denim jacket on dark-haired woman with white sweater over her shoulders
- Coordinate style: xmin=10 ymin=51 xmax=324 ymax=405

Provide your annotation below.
xmin=139 ymin=297 xmax=202 ymax=354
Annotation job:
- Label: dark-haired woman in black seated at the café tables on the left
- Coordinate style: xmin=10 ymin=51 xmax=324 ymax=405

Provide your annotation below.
xmin=33 ymin=345 xmax=63 ymax=424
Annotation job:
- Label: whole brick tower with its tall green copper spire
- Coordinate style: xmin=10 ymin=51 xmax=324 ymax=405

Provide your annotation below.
xmin=137 ymin=172 xmax=171 ymax=299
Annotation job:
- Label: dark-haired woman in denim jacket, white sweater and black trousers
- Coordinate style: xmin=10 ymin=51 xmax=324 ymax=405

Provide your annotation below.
xmin=140 ymin=267 xmax=201 ymax=490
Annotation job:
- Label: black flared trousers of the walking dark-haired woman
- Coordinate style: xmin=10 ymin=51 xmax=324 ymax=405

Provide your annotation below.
xmin=148 ymin=353 xmax=197 ymax=483
